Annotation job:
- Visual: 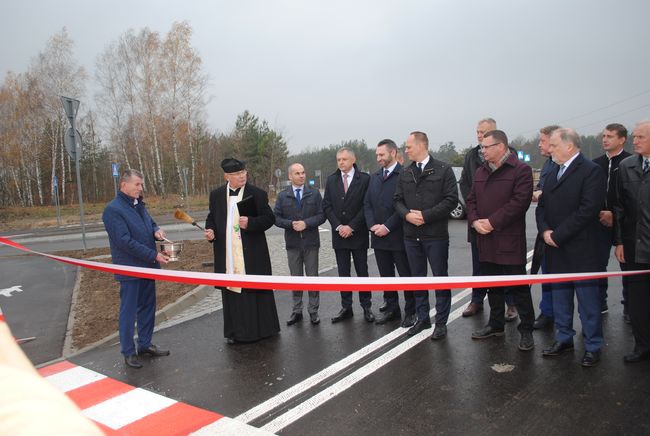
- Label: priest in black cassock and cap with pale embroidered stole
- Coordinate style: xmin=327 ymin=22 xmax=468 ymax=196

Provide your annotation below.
xmin=205 ymin=158 xmax=280 ymax=344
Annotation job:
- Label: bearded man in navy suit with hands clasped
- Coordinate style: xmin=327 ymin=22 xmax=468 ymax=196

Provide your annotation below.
xmin=363 ymin=139 xmax=415 ymax=327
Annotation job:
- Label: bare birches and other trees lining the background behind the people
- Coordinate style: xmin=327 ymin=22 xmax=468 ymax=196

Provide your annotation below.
xmin=0 ymin=22 xmax=630 ymax=207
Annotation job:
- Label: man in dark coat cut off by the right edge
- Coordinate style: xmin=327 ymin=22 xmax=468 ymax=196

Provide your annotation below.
xmin=614 ymin=121 xmax=650 ymax=363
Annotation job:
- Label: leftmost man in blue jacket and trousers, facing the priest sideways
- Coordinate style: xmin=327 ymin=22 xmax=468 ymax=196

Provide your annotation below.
xmin=102 ymin=169 xmax=169 ymax=368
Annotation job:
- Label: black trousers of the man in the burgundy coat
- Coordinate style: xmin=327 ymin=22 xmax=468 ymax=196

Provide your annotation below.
xmin=481 ymin=262 xmax=535 ymax=332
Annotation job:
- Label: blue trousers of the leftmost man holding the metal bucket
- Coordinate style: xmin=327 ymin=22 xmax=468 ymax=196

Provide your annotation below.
xmin=119 ymin=279 xmax=156 ymax=356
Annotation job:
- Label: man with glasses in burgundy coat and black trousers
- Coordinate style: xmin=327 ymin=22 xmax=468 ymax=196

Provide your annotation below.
xmin=467 ymin=130 xmax=535 ymax=351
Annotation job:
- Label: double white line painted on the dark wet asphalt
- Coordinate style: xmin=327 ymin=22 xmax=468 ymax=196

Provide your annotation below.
xmin=235 ymin=250 xmax=533 ymax=432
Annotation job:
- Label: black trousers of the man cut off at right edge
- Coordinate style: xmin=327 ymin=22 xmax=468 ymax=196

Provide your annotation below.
xmin=625 ymin=259 xmax=650 ymax=353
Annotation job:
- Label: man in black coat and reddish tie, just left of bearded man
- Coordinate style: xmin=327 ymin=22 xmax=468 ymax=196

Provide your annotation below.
xmin=323 ymin=147 xmax=375 ymax=323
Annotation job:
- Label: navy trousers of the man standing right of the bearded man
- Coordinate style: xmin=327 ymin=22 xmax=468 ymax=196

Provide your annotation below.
xmin=404 ymin=239 xmax=451 ymax=324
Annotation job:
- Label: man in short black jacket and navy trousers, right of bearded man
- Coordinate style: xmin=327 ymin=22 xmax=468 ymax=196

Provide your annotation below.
xmin=394 ymin=131 xmax=458 ymax=340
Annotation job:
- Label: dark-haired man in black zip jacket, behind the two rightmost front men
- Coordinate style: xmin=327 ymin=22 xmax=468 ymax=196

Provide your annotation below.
xmin=594 ymin=123 xmax=630 ymax=319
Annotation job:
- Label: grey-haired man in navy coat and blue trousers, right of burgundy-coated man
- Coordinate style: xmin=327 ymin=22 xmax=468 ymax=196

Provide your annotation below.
xmin=536 ymin=129 xmax=606 ymax=367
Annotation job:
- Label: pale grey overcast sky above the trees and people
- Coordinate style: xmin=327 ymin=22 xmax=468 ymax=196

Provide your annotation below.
xmin=0 ymin=0 xmax=650 ymax=152
